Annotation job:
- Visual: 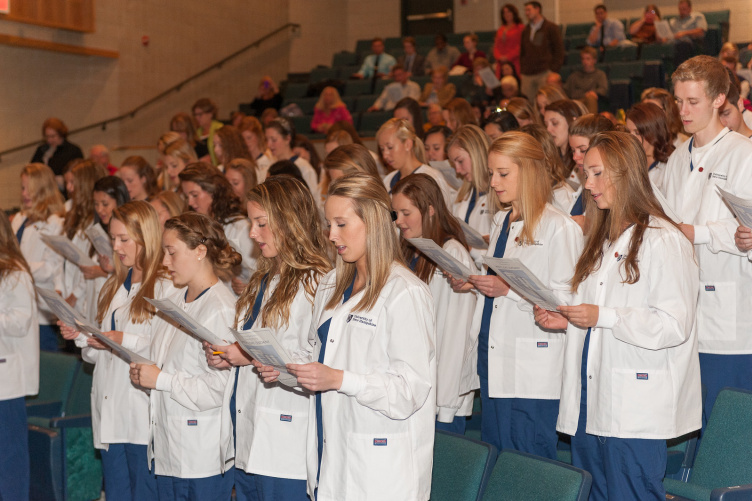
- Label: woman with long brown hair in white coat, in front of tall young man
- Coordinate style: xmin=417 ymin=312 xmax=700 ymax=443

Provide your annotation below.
xmin=536 ymin=132 xmax=702 ymax=501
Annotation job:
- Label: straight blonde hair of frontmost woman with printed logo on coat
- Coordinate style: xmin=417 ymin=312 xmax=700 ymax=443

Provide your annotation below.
xmin=326 ymin=174 xmax=405 ymax=311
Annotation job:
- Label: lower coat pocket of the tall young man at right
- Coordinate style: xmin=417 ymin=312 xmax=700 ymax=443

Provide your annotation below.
xmin=697 ymin=282 xmax=736 ymax=341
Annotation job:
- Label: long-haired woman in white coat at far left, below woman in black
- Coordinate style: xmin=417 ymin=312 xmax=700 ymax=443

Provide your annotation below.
xmin=11 ymin=163 xmax=65 ymax=351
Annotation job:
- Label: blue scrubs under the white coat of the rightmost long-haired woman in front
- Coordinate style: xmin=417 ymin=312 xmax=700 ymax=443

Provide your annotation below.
xmin=572 ymin=329 xmax=667 ymax=501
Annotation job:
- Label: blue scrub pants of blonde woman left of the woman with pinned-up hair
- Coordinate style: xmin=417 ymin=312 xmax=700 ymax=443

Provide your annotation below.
xmin=100 ymin=444 xmax=157 ymax=501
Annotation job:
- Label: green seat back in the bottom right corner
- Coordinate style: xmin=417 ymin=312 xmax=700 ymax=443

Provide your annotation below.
xmin=689 ymin=388 xmax=752 ymax=489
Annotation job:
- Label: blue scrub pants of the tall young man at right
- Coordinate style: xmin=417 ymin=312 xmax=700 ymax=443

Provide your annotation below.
xmin=700 ymin=353 xmax=752 ymax=433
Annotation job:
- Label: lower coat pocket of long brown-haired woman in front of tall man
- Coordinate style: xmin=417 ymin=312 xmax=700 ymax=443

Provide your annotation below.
xmin=611 ymin=369 xmax=674 ymax=438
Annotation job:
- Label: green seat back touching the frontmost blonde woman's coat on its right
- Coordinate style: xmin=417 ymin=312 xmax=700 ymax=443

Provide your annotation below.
xmin=431 ymin=431 xmax=496 ymax=501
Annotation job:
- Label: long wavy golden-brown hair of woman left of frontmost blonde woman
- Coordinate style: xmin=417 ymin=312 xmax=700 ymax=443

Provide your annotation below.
xmin=235 ymin=176 xmax=332 ymax=329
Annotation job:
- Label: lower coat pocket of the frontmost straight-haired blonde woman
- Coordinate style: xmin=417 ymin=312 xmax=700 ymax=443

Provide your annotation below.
xmin=345 ymin=432 xmax=417 ymax=500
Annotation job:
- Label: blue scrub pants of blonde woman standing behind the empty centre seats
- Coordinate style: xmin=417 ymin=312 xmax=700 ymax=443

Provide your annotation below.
xmin=480 ymin=378 xmax=559 ymax=460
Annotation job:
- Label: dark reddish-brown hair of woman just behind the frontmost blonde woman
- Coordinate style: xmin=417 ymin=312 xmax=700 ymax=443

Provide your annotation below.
xmin=392 ymin=174 xmax=469 ymax=283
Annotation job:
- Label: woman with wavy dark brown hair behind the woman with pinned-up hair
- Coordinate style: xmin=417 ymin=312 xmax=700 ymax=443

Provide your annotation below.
xmin=178 ymin=162 xmax=258 ymax=295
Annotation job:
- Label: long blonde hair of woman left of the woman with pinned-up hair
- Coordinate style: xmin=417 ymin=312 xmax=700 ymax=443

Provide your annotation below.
xmin=97 ymin=200 xmax=167 ymax=324
